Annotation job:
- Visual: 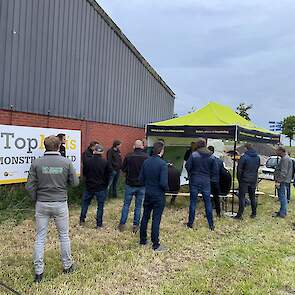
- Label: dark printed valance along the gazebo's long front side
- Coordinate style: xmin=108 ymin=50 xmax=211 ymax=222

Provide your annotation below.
xmin=147 ymin=125 xmax=236 ymax=139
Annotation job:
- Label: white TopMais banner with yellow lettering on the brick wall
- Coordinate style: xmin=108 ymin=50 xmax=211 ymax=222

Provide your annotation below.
xmin=0 ymin=125 xmax=81 ymax=185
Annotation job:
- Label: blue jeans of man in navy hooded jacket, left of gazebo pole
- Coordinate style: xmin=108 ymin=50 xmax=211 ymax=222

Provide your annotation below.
xmin=187 ymin=182 xmax=214 ymax=227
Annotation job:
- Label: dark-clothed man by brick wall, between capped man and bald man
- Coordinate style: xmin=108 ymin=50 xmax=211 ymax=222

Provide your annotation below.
xmin=107 ymin=139 xmax=122 ymax=198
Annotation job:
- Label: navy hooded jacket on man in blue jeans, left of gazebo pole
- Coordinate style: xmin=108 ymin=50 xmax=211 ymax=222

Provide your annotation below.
xmin=185 ymin=148 xmax=218 ymax=185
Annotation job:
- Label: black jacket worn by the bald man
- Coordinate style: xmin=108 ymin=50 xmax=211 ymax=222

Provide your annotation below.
xmin=122 ymin=149 xmax=148 ymax=186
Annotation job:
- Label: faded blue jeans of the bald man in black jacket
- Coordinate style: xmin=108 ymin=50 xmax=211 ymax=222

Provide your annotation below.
xmin=120 ymin=184 xmax=145 ymax=225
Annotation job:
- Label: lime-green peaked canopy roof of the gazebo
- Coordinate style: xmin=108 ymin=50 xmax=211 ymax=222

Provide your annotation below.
xmin=152 ymin=102 xmax=270 ymax=133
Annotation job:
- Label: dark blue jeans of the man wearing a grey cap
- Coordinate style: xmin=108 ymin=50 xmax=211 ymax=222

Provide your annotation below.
xmin=80 ymin=190 xmax=107 ymax=226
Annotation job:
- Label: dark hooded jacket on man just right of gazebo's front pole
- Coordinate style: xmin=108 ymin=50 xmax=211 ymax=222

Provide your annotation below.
xmin=238 ymin=149 xmax=260 ymax=183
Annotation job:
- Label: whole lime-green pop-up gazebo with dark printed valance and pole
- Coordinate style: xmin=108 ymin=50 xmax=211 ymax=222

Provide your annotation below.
xmin=146 ymin=102 xmax=280 ymax=216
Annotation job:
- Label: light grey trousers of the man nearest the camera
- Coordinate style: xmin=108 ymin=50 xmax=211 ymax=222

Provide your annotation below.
xmin=34 ymin=202 xmax=73 ymax=274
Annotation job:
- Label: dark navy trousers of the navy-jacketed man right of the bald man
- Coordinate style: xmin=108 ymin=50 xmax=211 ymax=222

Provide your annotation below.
xmin=140 ymin=194 xmax=165 ymax=250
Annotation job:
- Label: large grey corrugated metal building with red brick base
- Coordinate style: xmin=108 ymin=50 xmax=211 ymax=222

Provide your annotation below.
xmin=0 ymin=0 xmax=174 ymax=152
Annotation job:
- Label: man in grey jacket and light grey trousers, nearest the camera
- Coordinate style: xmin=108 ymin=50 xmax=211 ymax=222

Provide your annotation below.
xmin=26 ymin=135 xmax=79 ymax=283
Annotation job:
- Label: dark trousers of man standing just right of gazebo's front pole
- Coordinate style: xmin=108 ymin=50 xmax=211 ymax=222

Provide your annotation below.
xmin=237 ymin=182 xmax=257 ymax=217
